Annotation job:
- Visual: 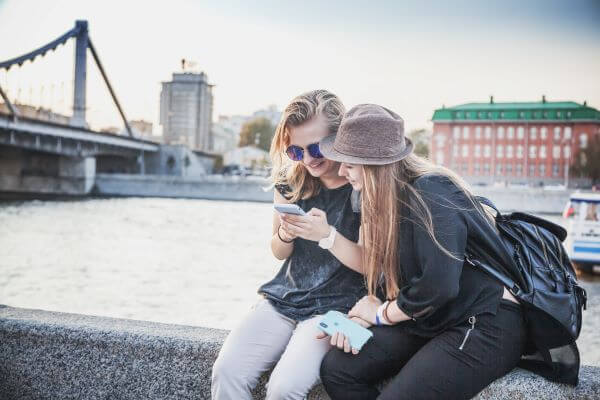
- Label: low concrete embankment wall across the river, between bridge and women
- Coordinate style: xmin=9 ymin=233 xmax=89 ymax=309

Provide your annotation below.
xmin=93 ymin=174 xmax=273 ymax=202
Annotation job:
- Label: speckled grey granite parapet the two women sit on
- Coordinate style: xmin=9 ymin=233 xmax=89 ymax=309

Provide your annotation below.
xmin=0 ymin=305 xmax=600 ymax=400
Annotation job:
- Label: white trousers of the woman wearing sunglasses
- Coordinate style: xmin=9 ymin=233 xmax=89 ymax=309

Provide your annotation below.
xmin=211 ymin=298 xmax=331 ymax=400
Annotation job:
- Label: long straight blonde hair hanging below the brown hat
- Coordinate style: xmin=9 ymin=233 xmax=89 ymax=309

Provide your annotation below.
xmin=361 ymin=154 xmax=494 ymax=299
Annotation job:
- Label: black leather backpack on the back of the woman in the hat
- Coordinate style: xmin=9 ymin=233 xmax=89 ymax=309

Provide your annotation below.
xmin=465 ymin=197 xmax=587 ymax=385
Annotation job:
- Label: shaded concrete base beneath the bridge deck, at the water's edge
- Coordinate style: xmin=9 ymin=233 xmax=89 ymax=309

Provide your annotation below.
xmin=0 ymin=146 xmax=96 ymax=196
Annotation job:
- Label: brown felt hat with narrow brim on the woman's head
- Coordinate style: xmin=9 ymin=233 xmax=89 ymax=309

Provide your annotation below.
xmin=319 ymin=104 xmax=413 ymax=165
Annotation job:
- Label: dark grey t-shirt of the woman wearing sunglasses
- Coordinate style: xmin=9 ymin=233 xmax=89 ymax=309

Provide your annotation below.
xmin=258 ymin=184 xmax=367 ymax=321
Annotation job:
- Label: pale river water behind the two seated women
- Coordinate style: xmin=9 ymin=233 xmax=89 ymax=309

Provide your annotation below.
xmin=0 ymin=198 xmax=600 ymax=366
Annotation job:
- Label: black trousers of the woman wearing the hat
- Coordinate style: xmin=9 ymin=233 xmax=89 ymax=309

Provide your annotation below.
xmin=321 ymin=299 xmax=526 ymax=400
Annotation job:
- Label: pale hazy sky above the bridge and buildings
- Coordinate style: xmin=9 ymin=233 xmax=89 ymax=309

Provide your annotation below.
xmin=0 ymin=0 xmax=600 ymax=133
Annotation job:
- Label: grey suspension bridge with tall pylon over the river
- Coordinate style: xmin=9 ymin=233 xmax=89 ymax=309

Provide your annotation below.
xmin=0 ymin=21 xmax=211 ymax=195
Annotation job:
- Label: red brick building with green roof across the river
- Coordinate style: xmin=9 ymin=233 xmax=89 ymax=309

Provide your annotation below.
xmin=430 ymin=97 xmax=600 ymax=184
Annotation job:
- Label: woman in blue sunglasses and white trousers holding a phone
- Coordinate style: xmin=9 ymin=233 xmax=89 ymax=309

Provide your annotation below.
xmin=212 ymin=90 xmax=366 ymax=400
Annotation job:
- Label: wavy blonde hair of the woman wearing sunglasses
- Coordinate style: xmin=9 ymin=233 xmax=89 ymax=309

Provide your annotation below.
xmin=270 ymin=89 xmax=346 ymax=202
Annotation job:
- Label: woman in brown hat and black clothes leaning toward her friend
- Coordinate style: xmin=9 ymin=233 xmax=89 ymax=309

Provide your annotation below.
xmin=320 ymin=104 xmax=526 ymax=400
